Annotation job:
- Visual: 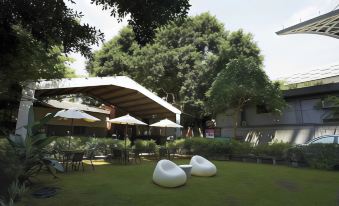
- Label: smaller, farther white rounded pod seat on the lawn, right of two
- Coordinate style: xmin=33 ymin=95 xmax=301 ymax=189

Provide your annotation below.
xmin=190 ymin=155 xmax=217 ymax=177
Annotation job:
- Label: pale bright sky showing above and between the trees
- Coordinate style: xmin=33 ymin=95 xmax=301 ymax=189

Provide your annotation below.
xmin=68 ymin=0 xmax=339 ymax=80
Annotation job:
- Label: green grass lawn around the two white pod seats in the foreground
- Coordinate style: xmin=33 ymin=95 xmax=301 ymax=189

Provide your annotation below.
xmin=20 ymin=160 xmax=339 ymax=206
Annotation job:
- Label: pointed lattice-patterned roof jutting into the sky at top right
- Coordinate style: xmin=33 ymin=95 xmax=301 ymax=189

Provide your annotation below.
xmin=277 ymin=9 xmax=339 ymax=38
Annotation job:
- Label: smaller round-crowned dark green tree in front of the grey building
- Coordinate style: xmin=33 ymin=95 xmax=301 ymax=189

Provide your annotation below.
xmin=206 ymin=57 xmax=286 ymax=137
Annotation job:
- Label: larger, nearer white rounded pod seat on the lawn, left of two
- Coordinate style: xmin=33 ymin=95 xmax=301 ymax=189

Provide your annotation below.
xmin=153 ymin=160 xmax=187 ymax=187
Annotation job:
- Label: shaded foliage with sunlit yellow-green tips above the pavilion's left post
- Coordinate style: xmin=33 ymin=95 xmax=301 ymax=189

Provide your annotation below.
xmin=0 ymin=26 xmax=74 ymax=99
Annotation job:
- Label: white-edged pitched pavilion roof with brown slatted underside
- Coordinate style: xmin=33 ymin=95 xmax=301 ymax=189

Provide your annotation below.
xmin=32 ymin=76 xmax=181 ymax=118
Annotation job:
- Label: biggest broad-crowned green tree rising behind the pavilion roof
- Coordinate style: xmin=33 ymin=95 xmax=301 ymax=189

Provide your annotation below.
xmin=87 ymin=13 xmax=262 ymax=126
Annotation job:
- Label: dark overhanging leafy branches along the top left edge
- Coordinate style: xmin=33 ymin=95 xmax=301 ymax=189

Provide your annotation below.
xmin=0 ymin=0 xmax=190 ymax=59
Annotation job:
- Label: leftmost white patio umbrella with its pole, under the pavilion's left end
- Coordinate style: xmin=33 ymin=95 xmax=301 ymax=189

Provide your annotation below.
xmin=54 ymin=108 xmax=101 ymax=148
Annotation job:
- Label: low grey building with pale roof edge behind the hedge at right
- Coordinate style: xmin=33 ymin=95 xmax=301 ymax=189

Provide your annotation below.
xmin=216 ymin=67 xmax=339 ymax=144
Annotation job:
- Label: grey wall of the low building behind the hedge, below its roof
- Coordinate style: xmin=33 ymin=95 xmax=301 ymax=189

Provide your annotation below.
xmin=216 ymin=98 xmax=339 ymax=144
